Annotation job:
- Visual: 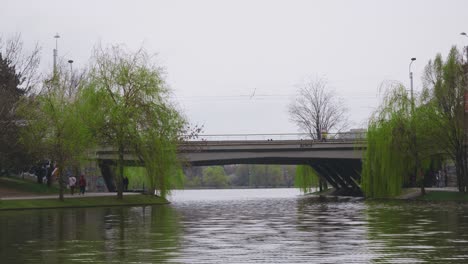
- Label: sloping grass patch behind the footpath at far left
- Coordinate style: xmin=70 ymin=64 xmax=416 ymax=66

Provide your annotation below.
xmin=0 ymin=177 xmax=59 ymax=194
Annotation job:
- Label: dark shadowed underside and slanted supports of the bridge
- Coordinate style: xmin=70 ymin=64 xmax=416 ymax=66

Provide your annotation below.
xmin=99 ymin=157 xmax=362 ymax=196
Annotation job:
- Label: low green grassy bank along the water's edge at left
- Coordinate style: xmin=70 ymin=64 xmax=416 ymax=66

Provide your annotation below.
xmin=0 ymin=195 xmax=168 ymax=210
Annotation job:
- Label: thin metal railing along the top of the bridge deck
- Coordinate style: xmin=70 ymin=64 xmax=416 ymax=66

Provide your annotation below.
xmin=189 ymin=132 xmax=366 ymax=142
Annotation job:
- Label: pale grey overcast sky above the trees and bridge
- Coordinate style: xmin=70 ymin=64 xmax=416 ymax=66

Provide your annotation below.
xmin=0 ymin=0 xmax=468 ymax=134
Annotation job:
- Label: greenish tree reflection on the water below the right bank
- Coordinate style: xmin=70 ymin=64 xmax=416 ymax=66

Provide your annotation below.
xmin=366 ymin=201 xmax=468 ymax=263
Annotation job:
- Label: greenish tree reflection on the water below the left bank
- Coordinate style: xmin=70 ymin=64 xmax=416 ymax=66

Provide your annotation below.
xmin=0 ymin=206 xmax=180 ymax=263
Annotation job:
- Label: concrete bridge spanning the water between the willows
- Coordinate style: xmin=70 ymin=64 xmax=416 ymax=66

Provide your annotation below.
xmin=95 ymin=134 xmax=366 ymax=193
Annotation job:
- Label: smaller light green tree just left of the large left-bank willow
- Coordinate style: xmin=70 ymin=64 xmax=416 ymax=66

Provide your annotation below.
xmin=17 ymin=67 xmax=94 ymax=200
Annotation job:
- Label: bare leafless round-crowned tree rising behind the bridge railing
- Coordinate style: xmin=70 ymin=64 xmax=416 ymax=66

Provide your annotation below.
xmin=288 ymin=79 xmax=347 ymax=140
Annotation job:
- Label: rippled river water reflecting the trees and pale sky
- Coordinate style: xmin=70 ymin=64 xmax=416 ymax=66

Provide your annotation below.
xmin=0 ymin=189 xmax=468 ymax=263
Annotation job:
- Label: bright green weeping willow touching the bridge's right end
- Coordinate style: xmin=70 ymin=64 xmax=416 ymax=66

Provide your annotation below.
xmin=361 ymin=86 xmax=414 ymax=197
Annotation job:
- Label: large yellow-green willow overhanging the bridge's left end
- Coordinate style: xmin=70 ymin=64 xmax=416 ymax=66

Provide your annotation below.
xmin=83 ymin=47 xmax=186 ymax=197
